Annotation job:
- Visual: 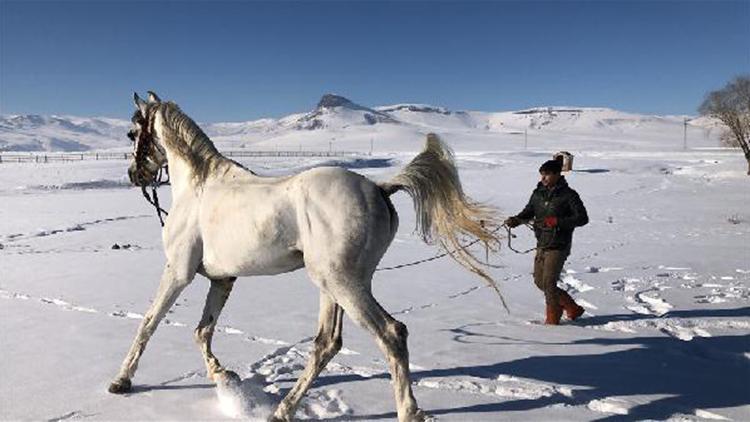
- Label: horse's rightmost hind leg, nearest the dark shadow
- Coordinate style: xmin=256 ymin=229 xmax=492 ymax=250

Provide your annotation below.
xmin=335 ymin=283 xmax=426 ymax=422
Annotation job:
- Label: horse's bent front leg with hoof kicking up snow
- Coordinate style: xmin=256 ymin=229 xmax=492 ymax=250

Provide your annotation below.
xmin=195 ymin=277 xmax=239 ymax=382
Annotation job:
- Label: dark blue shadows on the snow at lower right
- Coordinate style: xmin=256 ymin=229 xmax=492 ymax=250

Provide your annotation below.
xmin=314 ymin=307 xmax=750 ymax=421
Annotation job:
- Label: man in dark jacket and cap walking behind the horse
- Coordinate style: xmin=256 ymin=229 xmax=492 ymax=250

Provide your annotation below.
xmin=505 ymin=160 xmax=589 ymax=325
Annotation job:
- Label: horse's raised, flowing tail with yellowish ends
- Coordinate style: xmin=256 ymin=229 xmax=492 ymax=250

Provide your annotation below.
xmin=380 ymin=133 xmax=507 ymax=309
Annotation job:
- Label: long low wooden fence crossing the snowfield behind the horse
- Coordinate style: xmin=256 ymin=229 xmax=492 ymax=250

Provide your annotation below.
xmin=0 ymin=150 xmax=367 ymax=164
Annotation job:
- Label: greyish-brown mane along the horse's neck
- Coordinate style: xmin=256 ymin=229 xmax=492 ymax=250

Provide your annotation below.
xmin=156 ymin=102 xmax=233 ymax=185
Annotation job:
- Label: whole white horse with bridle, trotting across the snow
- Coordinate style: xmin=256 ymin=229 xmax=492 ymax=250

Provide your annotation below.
xmin=109 ymin=92 xmax=506 ymax=421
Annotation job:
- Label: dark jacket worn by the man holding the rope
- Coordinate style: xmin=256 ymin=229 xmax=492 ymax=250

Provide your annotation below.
xmin=516 ymin=177 xmax=589 ymax=251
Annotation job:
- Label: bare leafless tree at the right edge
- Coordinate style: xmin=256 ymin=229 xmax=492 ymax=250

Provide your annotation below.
xmin=698 ymin=75 xmax=750 ymax=175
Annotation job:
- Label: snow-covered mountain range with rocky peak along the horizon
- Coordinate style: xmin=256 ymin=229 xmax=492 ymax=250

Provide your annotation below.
xmin=0 ymin=94 xmax=721 ymax=151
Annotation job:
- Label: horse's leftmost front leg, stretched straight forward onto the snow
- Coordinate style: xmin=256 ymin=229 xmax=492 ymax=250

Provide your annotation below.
xmin=109 ymin=264 xmax=195 ymax=394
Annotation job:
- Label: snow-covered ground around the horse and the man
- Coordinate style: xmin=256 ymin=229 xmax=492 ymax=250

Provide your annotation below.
xmin=0 ymin=104 xmax=750 ymax=421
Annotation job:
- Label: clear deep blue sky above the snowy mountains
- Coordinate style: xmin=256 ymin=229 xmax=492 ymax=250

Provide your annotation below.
xmin=0 ymin=0 xmax=750 ymax=122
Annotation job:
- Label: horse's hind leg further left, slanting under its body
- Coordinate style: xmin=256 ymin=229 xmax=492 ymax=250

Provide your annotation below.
xmin=271 ymin=291 xmax=344 ymax=421
